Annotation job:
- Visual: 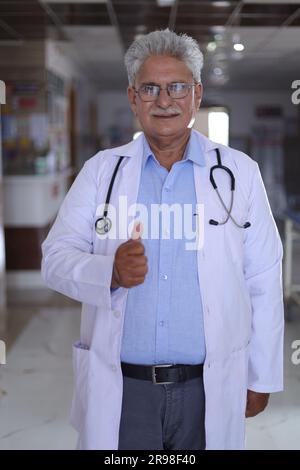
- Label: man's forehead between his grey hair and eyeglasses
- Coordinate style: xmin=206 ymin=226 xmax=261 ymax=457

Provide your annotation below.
xmin=136 ymin=55 xmax=193 ymax=83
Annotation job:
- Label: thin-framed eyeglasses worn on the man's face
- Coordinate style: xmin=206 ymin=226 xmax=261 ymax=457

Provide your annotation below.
xmin=133 ymin=83 xmax=197 ymax=101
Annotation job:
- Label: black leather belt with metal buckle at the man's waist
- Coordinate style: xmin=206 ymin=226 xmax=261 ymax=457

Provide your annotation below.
xmin=121 ymin=362 xmax=203 ymax=385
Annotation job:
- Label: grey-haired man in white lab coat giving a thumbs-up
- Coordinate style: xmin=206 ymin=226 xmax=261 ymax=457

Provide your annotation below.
xmin=42 ymin=30 xmax=283 ymax=450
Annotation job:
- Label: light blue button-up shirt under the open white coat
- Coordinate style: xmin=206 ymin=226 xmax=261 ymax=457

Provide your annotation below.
xmin=121 ymin=132 xmax=205 ymax=365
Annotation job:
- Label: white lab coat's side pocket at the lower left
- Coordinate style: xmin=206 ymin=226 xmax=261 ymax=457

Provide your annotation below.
xmin=70 ymin=342 xmax=90 ymax=432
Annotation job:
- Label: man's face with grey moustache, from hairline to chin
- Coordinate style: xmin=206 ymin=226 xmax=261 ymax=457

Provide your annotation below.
xmin=128 ymin=56 xmax=202 ymax=139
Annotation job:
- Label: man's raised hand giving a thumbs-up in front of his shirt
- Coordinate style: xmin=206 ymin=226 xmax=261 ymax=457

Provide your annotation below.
xmin=111 ymin=223 xmax=148 ymax=288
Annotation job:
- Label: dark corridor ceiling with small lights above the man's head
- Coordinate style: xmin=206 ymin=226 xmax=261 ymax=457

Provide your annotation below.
xmin=0 ymin=0 xmax=300 ymax=89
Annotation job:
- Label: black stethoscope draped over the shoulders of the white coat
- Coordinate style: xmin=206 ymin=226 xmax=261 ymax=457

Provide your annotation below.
xmin=95 ymin=149 xmax=251 ymax=235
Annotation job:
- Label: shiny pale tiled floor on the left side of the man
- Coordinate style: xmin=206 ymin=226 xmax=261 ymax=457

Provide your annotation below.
xmin=0 ymin=291 xmax=80 ymax=449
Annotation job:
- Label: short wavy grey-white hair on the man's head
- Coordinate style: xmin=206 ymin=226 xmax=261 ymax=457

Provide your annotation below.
xmin=125 ymin=28 xmax=203 ymax=86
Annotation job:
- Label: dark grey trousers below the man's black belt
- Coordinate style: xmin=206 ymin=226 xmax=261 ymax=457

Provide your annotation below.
xmin=118 ymin=376 xmax=205 ymax=450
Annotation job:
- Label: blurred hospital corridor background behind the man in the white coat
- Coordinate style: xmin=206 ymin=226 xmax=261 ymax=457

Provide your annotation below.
xmin=0 ymin=0 xmax=300 ymax=449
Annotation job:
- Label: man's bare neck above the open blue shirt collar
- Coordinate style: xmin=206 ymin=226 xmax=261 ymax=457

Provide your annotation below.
xmin=146 ymin=129 xmax=191 ymax=171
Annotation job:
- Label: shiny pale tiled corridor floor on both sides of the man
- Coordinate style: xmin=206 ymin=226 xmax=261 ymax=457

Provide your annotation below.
xmin=0 ymin=284 xmax=300 ymax=449
